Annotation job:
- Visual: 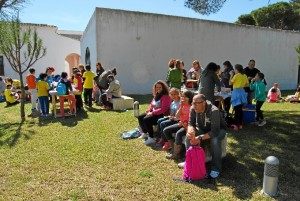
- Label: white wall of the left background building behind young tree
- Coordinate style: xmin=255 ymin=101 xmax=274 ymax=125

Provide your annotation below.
xmin=4 ymin=25 xmax=80 ymax=79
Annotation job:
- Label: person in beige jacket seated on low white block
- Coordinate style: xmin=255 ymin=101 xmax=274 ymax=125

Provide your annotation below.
xmin=101 ymin=74 xmax=122 ymax=109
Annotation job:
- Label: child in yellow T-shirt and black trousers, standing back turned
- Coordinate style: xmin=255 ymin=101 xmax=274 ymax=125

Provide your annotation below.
xmin=82 ymin=65 xmax=96 ymax=107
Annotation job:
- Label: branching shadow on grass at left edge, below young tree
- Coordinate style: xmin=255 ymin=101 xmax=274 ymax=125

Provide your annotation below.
xmin=0 ymin=120 xmax=35 ymax=147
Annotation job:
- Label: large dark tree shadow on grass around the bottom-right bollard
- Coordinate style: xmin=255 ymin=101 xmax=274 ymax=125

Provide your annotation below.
xmin=219 ymin=111 xmax=300 ymax=200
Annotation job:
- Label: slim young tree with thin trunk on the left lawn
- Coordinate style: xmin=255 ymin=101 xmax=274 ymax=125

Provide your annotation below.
xmin=0 ymin=18 xmax=46 ymax=120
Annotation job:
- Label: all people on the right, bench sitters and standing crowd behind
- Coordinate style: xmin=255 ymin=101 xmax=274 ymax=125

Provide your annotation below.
xmin=138 ymin=59 xmax=299 ymax=178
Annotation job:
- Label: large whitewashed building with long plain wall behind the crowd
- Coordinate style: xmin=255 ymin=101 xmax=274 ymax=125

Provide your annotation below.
xmin=81 ymin=8 xmax=300 ymax=94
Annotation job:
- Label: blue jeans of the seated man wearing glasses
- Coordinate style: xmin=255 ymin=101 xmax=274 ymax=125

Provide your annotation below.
xmin=185 ymin=129 xmax=226 ymax=172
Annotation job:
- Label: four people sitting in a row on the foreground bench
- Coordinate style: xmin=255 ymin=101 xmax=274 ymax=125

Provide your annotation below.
xmin=138 ymin=80 xmax=226 ymax=178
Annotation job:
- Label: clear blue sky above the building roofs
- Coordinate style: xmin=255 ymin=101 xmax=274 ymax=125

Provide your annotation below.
xmin=20 ymin=0 xmax=288 ymax=31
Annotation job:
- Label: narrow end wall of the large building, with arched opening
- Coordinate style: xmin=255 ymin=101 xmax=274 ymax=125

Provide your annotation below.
xmin=80 ymin=10 xmax=98 ymax=72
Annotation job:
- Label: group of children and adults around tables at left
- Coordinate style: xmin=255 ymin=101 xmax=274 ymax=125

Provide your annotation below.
xmin=0 ymin=62 xmax=122 ymax=117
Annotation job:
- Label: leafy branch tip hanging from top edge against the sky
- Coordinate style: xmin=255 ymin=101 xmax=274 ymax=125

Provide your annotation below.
xmin=184 ymin=0 xmax=226 ymax=15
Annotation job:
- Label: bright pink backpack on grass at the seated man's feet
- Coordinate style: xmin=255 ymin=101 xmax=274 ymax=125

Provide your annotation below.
xmin=183 ymin=146 xmax=206 ymax=182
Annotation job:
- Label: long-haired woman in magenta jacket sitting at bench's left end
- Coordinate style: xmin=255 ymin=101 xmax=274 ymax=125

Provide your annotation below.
xmin=138 ymin=80 xmax=171 ymax=145
